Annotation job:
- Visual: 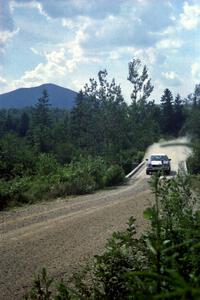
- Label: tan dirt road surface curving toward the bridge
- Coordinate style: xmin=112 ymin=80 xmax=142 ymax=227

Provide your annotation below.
xmin=0 ymin=139 xmax=190 ymax=300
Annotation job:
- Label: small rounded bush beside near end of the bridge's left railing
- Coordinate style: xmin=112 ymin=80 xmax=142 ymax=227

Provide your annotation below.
xmin=104 ymin=165 xmax=125 ymax=186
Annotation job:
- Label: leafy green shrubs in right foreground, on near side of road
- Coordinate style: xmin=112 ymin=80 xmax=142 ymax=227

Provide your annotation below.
xmin=25 ymin=176 xmax=200 ymax=300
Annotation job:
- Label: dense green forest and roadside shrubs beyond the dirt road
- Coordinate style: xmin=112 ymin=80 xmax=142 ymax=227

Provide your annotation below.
xmin=0 ymin=59 xmax=200 ymax=208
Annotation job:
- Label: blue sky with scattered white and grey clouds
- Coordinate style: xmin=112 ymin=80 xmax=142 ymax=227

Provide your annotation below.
xmin=0 ymin=0 xmax=200 ymax=102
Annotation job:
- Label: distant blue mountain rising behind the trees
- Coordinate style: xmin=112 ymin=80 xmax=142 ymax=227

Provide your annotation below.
xmin=0 ymin=83 xmax=77 ymax=109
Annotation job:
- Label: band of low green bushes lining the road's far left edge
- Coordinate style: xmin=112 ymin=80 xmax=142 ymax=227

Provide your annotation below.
xmin=0 ymin=154 xmax=124 ymax=209
